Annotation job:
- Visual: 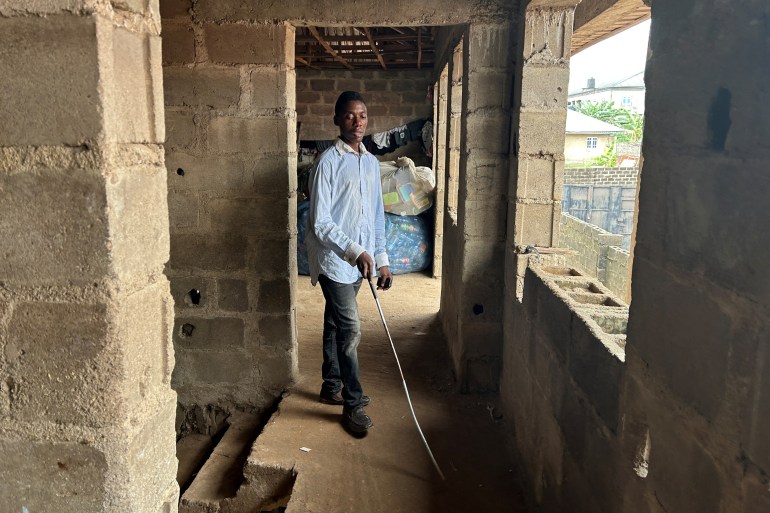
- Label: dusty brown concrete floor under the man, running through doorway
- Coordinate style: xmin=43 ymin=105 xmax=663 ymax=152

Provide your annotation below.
xmin=244 ymin=274 xmax=524 ymax=513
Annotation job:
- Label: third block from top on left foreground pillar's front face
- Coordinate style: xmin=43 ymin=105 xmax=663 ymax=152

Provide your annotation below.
xmin=5 ymin=303 xmax=123 ymax=426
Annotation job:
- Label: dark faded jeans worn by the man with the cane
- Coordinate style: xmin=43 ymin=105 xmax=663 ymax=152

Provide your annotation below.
xmin=318 ymin=274 xmax=363 ymax=409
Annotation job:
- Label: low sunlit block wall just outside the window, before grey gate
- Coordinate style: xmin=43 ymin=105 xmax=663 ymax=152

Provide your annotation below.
xmin=559 ymin=213 xmax=628 ymax=284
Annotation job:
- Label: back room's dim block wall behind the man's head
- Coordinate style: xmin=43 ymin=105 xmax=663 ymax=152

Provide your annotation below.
xmin=297 ymin=68 xmax=433 ymax=144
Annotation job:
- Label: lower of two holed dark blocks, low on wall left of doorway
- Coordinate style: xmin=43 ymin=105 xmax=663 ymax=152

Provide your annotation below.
xmin=174 ymin=317 xmax=243 ymax=352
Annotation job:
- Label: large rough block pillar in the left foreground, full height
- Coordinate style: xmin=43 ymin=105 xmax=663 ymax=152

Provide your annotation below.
xmin=0 ymin=2 xmax=178 ymax=513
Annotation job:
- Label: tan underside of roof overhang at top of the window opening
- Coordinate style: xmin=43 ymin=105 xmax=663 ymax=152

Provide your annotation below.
xmin=572 ymin=0 xmax=650 ymax=54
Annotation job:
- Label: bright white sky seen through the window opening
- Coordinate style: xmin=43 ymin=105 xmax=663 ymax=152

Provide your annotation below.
xmin=569 ymin=20 xmax=650 ymax=92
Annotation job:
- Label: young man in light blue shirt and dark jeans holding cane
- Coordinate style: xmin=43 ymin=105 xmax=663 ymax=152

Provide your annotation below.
xmin=305 ymin=91 xmax=393 ymax=433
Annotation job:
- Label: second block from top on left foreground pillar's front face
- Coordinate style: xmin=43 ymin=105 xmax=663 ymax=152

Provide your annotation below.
xmin=0 ymin=170 xmax=108 ymax=286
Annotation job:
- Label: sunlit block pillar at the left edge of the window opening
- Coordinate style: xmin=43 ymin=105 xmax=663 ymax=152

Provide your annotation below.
xmin=506 ymin=1 xmax=575 ymax=298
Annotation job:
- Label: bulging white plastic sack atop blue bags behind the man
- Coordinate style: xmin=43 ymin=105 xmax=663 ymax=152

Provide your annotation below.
xmin=380 ymin=157 xmax=436 ymax=216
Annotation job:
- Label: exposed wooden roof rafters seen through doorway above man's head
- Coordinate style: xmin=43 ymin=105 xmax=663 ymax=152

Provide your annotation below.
xmin=295 ymin=26 xmax=435 ymax=70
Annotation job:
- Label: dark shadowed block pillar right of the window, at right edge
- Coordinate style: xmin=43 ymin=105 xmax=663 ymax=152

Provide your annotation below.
xmin=623 ymin=0 xmax=770 ymax=513
